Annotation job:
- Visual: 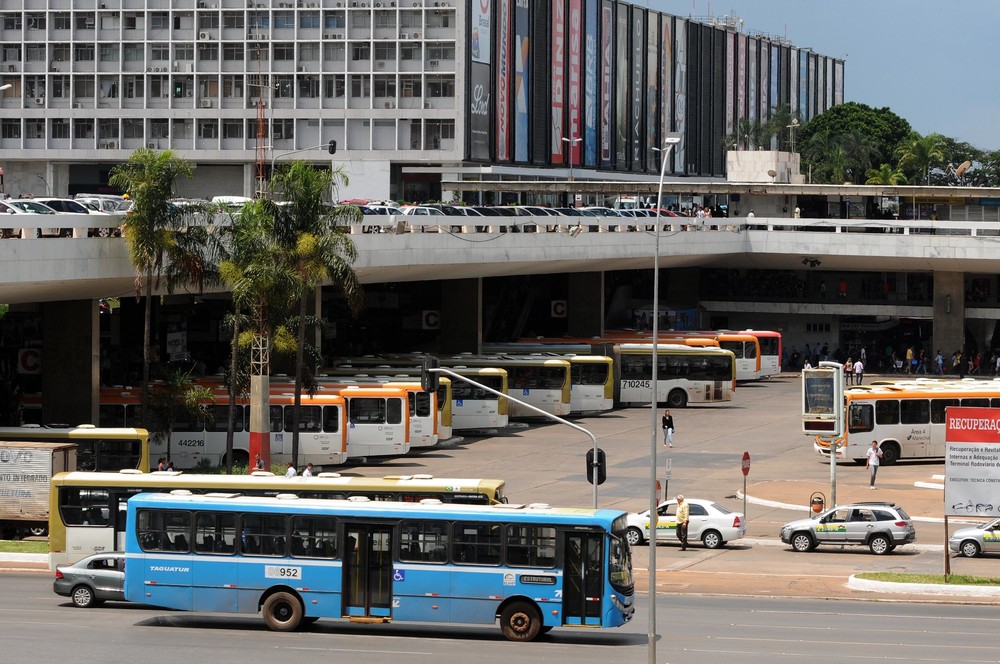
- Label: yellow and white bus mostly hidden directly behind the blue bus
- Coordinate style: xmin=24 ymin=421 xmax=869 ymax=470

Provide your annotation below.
xmin=48 ymin=471 xmax=507 ymax=568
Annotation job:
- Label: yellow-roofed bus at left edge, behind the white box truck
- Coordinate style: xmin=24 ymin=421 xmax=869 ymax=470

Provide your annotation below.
xmin=0 ymin=424 xmax=150 ymax=473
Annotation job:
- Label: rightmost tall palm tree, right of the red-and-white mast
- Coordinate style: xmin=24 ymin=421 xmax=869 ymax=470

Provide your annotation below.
xmin=272 ymin=161 xmax=364 ymax=465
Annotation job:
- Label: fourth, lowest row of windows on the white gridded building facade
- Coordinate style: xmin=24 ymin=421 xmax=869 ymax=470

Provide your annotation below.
xmin=0 ymin=118 xmax=455 ymax=142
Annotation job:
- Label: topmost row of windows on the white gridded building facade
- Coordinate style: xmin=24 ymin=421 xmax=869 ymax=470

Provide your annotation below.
xmin=0 ymin=8 xmax=454 ymax=30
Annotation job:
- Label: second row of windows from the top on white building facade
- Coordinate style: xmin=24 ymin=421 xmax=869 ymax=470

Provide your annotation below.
xmin=0 ymin=40 xmax=455 ymax=64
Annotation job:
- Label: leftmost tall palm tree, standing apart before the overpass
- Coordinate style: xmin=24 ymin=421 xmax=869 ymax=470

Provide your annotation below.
xmin=108 ymin=148 xmax=194 ymax=428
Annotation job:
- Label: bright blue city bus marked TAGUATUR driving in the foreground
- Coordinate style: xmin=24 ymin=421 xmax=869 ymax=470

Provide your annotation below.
xmin=125 ymin=491 xmax=635 ymax=641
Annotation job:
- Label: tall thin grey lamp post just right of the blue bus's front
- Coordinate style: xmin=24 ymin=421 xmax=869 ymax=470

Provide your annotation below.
xmin=646 ymin=132 xmax=681 ymax=664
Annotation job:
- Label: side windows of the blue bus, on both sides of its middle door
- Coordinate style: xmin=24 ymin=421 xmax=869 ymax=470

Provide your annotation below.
xmin=136 ymin=510 xmax=556 ymax=568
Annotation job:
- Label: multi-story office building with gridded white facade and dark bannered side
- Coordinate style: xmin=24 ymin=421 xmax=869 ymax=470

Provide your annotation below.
xmin=0 ymin=0 xmax=844 ymax=200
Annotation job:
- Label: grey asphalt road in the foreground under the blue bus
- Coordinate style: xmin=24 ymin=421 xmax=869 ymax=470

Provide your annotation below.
xmin=7 ymin=574 xmax=1000 ymax=664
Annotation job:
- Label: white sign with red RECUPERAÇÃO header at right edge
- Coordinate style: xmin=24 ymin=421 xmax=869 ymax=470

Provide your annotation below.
xmin=944 ymin=406 xmax=1000 ymax=517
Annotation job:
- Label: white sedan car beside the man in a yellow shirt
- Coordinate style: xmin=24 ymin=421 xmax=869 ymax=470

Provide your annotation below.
xmin=626 ymin=498 xmax=747 ymax=549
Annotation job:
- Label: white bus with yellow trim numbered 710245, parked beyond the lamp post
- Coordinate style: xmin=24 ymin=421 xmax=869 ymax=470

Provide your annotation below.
xmin=618 ymin=344 xmax=736 ymax=408
